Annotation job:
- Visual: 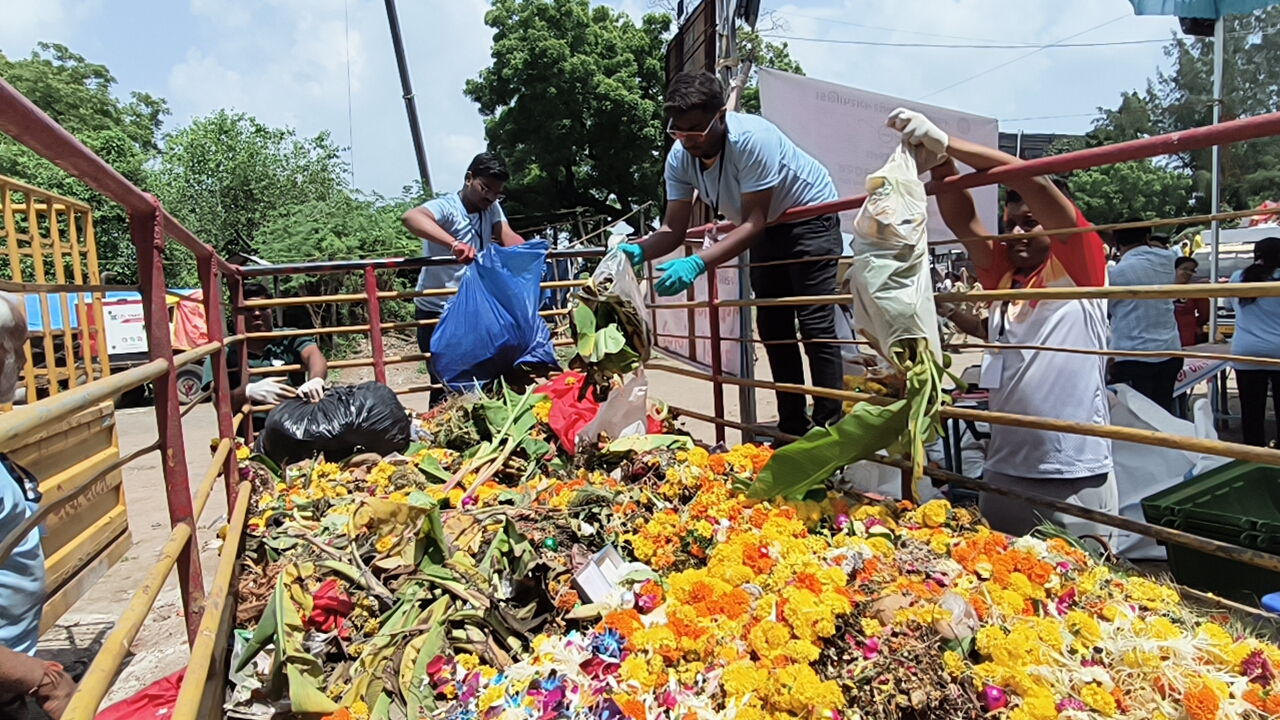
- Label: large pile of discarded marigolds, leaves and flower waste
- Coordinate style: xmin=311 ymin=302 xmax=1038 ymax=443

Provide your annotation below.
xmin=227 ymin=392 xmax=1280 ymax=720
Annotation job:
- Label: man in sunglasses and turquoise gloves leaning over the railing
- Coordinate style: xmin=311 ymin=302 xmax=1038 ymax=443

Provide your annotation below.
xmin=622 ymin=72 xmax=844 ymax=436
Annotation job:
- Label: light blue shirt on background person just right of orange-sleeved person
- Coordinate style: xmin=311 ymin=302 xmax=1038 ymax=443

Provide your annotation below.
xmin=1107 ymin=246 xmax=1183 ymax=363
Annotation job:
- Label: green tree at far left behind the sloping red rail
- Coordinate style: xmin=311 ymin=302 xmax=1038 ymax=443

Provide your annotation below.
xmin=0 ymin=42 xmax=169 ymax=283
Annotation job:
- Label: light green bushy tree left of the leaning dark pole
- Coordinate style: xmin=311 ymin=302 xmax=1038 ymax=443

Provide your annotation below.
xmin=151 ymin=110 xmax=347 ymax=258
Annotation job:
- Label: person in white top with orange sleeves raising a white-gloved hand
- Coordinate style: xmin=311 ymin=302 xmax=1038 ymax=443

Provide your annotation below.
xmin=888 ymin=110 xmax=1120 ymax=542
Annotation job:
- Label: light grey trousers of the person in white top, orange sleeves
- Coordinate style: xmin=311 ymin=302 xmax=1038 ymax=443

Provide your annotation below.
xmin=978 ymin=469 xmax=1120 ymax=548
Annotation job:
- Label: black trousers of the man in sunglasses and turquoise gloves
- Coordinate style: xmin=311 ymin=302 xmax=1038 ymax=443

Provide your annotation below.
xmin=751 ymin=214 xmax=844 ymax=436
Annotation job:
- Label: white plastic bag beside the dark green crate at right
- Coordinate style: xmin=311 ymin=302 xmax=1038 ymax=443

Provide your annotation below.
xmin=1111 ymin=384 xmax=1229 ymax=560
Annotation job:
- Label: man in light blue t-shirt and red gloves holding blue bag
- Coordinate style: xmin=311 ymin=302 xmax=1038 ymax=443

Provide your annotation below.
xmin=401 ymin=152 xmax=525 ymax=405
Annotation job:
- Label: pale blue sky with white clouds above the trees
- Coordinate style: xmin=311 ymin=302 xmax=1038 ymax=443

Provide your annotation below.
xmin=0 ymin=0 xmax=1178 ymax=196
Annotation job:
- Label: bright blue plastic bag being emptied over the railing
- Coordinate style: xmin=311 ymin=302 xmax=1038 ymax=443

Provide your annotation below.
xmin=431 ymin=240 xmax=559 ymax=389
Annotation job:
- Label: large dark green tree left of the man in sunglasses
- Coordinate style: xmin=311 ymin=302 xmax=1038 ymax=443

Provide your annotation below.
xmin=465 ymin=0 xmax=671 ymax=219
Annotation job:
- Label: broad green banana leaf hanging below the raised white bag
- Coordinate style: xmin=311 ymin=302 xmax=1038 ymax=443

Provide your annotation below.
xmin=748 ymin=392 xmax=910 ymax=498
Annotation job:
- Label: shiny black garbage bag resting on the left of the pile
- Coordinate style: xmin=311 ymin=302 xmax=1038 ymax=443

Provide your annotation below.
xmin=257 ymin=382 xmax=413 ymax=468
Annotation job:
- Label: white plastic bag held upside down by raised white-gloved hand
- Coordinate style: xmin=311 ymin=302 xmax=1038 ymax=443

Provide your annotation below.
xmin=852 ymin=143 xmax=942 ymax=363
